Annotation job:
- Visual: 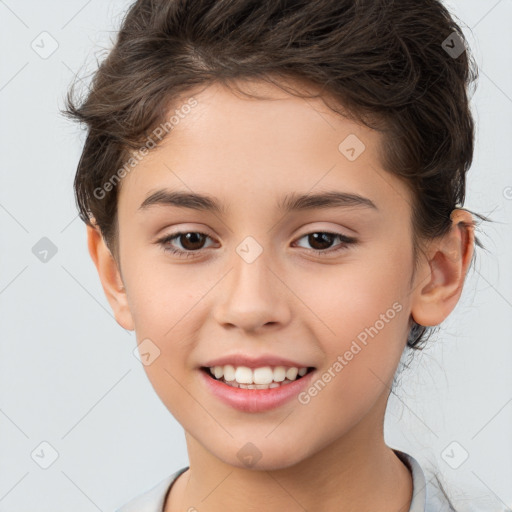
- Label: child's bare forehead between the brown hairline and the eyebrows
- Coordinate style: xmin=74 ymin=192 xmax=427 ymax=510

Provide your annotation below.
xmin=119 ymin=82 xmax=408 ymax=219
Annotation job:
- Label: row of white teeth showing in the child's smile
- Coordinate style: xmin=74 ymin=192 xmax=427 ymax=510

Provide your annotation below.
xmin=210 ymin=364 xmax=308 ymax=389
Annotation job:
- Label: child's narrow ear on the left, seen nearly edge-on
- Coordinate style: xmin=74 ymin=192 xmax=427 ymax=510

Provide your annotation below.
xmin=87 ymin=226 xmax=135 ymax=331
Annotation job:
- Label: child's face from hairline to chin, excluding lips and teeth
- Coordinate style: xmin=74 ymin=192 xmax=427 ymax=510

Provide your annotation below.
xmin=112 ymin=82 xmax=417 ymax=468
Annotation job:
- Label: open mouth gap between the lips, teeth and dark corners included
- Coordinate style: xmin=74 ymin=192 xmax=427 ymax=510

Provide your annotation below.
xmin=199 ymin=366 xmax=315 ymax=390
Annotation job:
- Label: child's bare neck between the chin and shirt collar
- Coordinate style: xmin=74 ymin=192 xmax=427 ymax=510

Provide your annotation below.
xmin=165 ymin=412 xmax=413 ymax=512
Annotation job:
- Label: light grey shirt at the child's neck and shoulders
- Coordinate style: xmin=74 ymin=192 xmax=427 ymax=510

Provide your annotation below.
xmin=116 ymin=449 xmax=512 ymax=512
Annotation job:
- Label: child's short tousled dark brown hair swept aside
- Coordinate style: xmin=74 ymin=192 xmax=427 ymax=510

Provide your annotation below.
xmin=65 ymin=0 xmax=488 ymax=356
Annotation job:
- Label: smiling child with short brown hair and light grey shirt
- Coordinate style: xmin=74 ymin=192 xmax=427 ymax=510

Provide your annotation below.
xmin=64 ymin=0 xmax=504 ymax=512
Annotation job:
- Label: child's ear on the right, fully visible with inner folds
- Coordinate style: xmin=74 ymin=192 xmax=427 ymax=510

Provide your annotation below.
xmin=411 ymin=209 xmax=475 ymax=326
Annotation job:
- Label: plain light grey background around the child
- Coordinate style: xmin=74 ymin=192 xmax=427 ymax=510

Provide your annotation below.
xmin=0 ymin=0 xmax=512 ymax=512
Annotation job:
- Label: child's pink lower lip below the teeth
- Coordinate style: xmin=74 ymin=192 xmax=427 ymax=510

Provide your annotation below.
xmin=199 ymin=370 xmax=315 ymax=412
